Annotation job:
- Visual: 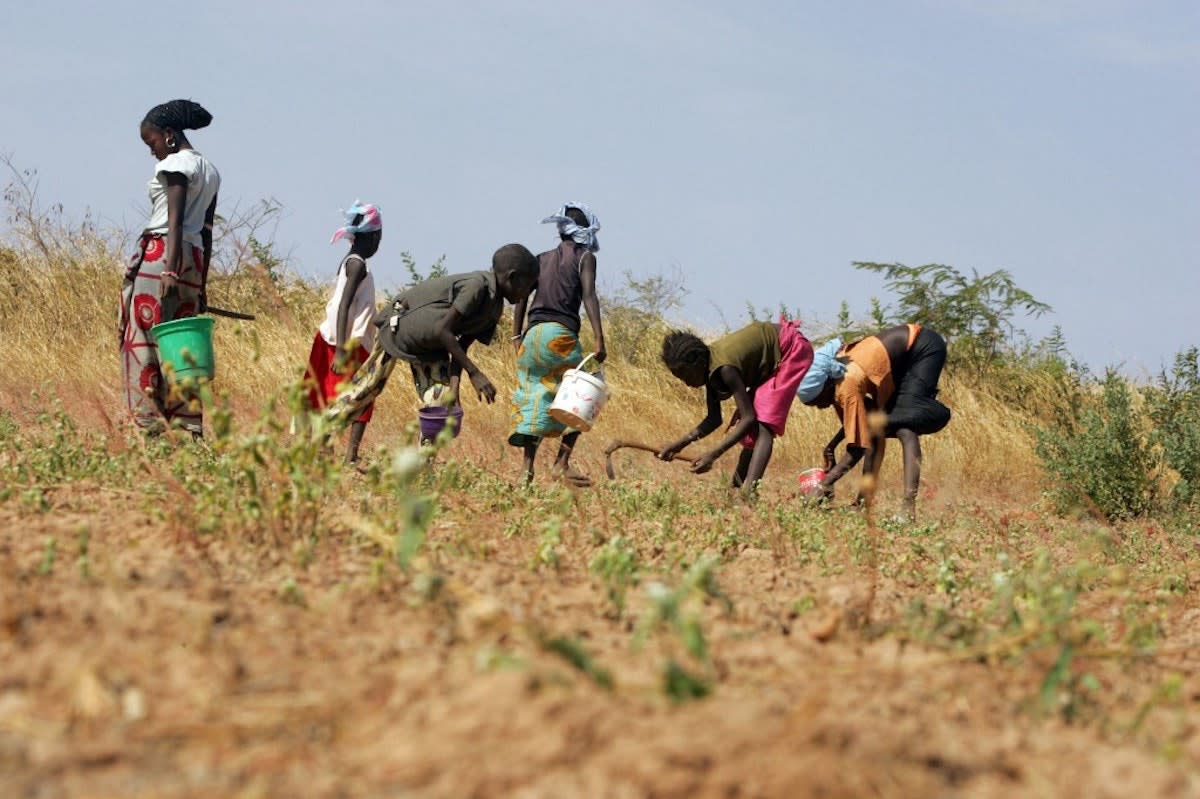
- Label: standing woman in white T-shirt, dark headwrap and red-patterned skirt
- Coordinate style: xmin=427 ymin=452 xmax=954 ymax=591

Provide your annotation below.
xmin=120 ymin=100 xmax=221 ymax=438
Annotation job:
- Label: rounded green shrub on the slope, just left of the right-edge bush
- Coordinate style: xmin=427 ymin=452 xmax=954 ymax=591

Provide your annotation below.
xmin=1037 ymin=371 xmax=1157 ymax=519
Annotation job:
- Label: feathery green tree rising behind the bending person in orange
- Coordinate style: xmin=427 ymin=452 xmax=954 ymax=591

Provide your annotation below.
xmin=854 ymin=260 xmax=1051 ymax=376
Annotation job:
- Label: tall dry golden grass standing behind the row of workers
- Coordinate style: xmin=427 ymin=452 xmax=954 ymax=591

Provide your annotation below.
xmin=0 ymin=229 xmax=1039 ymax=501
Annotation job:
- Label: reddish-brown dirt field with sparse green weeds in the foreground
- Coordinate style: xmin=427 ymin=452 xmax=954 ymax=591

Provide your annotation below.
xmin=0 ymin=419 xmax=1200 ymax=798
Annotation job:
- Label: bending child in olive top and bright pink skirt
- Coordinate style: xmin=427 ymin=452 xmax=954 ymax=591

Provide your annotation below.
xmin=658 ymin=317 xmax=812 ymax=493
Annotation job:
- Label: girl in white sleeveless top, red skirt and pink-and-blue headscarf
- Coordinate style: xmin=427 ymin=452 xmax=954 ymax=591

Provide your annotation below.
xmin=305 ymin=200 xmax=383 ymax=463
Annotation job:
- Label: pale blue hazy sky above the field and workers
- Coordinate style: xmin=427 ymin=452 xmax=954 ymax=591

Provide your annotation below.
xmin=0 ymin=0 xmax=1200 ymax=373
